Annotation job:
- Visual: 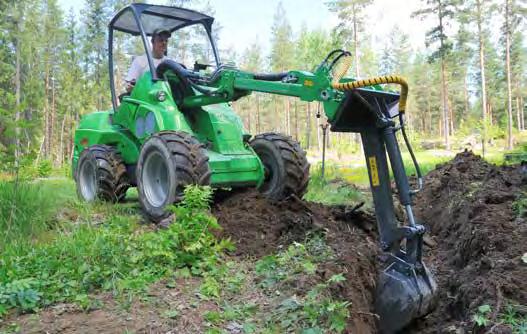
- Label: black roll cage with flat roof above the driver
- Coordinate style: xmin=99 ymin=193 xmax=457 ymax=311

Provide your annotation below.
xmin=108 ymin=3 xmax=219 ymax=111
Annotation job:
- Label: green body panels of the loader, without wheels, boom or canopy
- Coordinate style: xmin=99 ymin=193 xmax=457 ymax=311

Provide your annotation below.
xmin=72 ymin=72 xmax=264 ymax=187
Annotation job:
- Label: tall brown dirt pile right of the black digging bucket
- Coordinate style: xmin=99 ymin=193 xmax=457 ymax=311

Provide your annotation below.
xmin=415 ymin=152 xmax=527 ymax=333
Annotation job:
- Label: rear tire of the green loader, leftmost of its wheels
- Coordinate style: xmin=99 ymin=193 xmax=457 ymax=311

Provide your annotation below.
xmin=75 ymin=145 xmax=130 ymax=203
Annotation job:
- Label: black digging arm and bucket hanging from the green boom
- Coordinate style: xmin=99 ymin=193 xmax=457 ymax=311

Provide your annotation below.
xmin=330 ymin=89 xmax=437 ymax=333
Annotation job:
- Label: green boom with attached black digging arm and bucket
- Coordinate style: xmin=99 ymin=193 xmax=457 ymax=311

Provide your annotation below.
xmin=163 ymin=50 xmax=437 ymax=333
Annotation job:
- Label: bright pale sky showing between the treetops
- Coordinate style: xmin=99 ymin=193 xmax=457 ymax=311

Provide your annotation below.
xmin=59 ymin=0 xmax=431 ymax=54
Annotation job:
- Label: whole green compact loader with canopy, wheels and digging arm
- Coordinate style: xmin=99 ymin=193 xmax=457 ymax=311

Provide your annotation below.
xmin=72 ymin=4 xmax=437 ymax=333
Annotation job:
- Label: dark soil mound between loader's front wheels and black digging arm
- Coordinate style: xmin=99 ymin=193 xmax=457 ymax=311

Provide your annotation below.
xmin=213 ymin=191 xmax=378 ymax=333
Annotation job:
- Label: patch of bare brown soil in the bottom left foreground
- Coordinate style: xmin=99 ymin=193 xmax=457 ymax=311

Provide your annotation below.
xmin=10 ymin=278 xmax=219 ymax=334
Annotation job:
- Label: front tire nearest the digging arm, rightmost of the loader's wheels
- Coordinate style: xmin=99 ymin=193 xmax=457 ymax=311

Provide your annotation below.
xmin=250 ymin=132 xmax=309 ymax=200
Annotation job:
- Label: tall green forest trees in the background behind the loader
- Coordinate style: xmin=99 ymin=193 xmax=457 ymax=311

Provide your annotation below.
xmin=0 ymin=0 xmax=527 ymax=171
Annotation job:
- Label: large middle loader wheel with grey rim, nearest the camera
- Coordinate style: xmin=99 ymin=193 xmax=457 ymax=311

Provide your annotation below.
xmin=136 ymin=131 xmax=212 ymax=222
